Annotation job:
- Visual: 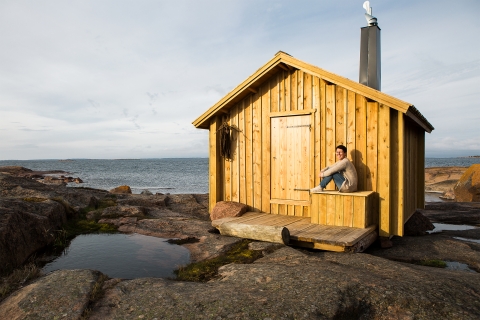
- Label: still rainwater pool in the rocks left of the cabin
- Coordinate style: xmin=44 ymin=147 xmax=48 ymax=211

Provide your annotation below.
xmin=42 ymin=234 xmax=190 ymax=279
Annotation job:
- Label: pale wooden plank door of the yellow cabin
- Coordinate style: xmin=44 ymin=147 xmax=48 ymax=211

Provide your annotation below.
xmin=270 ymin=115 xmax=313 ymax=201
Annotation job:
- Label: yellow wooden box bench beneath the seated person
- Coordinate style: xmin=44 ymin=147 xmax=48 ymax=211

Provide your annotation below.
xmin=310 ymin=191 xmax=378 ymax=228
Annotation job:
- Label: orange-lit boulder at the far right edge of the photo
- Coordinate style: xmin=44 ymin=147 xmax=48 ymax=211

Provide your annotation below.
xmin=453 ymin=164 xmax=480 ymax=202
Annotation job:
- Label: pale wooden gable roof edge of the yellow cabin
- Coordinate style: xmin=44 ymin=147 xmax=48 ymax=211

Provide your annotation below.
xmin=193 ymin=51 xmax=434 ymax=133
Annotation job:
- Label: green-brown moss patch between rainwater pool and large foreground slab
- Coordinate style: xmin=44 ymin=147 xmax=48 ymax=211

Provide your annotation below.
xmin=174 ymin=240 xmax=263 ymax=282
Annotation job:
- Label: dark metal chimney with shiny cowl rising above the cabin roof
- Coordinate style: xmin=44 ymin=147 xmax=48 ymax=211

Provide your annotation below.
xmin=359 ymin=1 xmax=381 ymax=91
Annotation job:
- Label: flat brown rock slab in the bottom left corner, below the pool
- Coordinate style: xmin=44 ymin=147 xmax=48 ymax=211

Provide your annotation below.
xmin=0 ymin=270 xmax=101 ymax=320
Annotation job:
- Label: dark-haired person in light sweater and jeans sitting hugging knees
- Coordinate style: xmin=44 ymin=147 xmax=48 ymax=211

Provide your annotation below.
xmin=310 ymin=145 xmax=357 ymax=193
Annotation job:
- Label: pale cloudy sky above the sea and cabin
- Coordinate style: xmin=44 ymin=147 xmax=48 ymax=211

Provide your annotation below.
xmin=0 ymin=0 xmax=480 ymax=160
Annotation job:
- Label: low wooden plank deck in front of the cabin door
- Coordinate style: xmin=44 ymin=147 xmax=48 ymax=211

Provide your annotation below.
xmin=212 ymin=212 xmax=377 ymax=252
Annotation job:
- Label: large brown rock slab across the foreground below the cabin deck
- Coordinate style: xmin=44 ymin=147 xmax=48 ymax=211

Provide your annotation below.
xmin=90 ymin=247 xmax=480 ymax=319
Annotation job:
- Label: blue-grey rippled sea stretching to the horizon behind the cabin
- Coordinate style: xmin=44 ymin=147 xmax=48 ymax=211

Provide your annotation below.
xmin=0 ymin=157 xmax=480 ymax=194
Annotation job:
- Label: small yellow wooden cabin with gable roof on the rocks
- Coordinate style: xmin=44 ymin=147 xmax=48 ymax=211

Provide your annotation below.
xmin=193 ymin=51 xmax=434 ymax=251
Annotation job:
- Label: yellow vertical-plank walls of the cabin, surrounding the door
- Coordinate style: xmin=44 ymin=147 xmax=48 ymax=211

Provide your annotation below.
xmin=210 ymin=69 xmax=424 ymax=236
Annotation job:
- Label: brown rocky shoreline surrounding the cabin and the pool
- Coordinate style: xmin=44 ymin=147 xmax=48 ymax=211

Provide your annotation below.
xmin=0 ymin=168 xmax=480 ymax=319
